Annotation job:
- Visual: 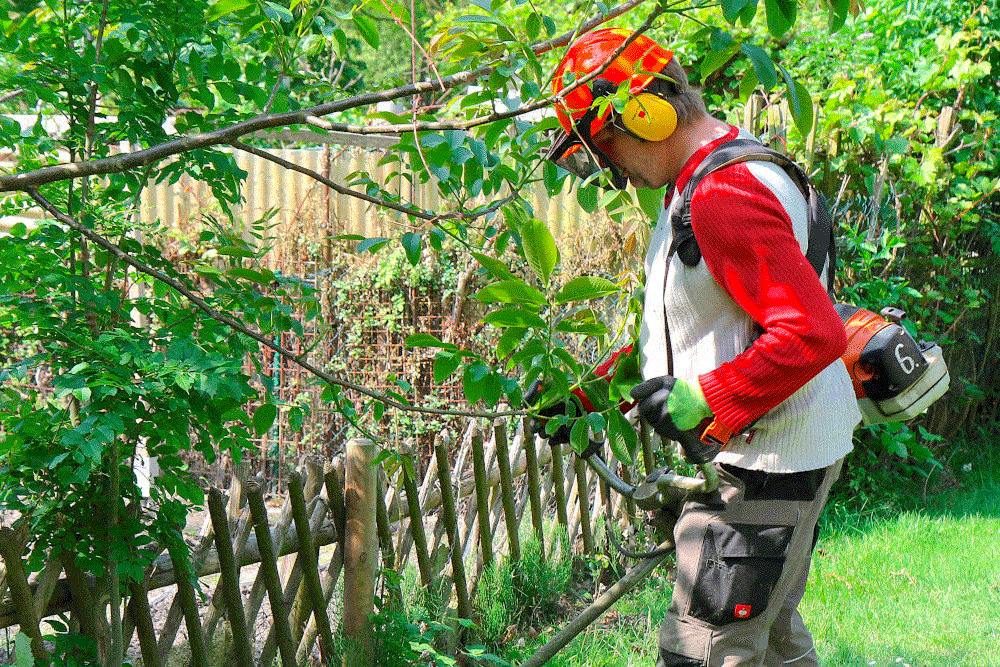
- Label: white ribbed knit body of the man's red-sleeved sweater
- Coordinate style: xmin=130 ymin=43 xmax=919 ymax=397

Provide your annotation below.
xmin=639 ymin=145 xmax=861 ymax=472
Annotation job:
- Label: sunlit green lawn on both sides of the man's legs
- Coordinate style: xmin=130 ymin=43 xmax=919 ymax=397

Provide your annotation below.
xmin=507 ymin=462 xmax=1000 ymax=667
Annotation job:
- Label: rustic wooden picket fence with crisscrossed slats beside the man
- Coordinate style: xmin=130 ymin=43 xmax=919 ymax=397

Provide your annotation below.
xmin=0 ymin=419 xmax=652 ymax=667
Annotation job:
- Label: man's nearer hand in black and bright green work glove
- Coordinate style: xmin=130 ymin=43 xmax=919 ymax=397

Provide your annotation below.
xmin=630 ymin=375 xmax=721 ymax=463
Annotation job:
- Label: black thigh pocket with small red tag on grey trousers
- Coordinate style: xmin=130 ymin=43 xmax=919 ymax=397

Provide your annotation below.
xmin=688 ymin=523 xmax=794 ymax=626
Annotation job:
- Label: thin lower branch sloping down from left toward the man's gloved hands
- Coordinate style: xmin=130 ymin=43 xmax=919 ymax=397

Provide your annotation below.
xmin=27 ymin=189 xmax=526 ymax=419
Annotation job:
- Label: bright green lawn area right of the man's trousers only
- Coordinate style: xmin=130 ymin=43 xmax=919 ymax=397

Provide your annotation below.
xmin=802 ymin=474 xmax=1000 ymax=667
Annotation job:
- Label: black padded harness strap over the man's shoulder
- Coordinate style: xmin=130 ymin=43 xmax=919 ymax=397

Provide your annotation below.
xmin=667 ymin=139 xmax=837 ymax=294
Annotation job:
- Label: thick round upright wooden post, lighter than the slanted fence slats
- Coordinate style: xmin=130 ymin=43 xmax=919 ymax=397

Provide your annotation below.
xmin=343 ymin=439 xmax=378 ymax=667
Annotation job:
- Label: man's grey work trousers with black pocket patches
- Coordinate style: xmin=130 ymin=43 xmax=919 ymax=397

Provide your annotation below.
xmin=657 ymin=460 xmax=843 ymax=667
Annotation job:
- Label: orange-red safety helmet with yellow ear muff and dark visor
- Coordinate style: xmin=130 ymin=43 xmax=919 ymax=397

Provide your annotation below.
xmin=547 ymin=28 xmax=676 ymax=188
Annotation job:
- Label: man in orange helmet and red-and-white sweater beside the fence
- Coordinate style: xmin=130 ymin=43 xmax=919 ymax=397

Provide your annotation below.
xmin=550 ymin=29 xmax=860 ymax=667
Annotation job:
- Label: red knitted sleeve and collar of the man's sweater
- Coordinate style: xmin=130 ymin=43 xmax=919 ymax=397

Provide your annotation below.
xmin=677 ymin=128 xmax=847 ymax=432
